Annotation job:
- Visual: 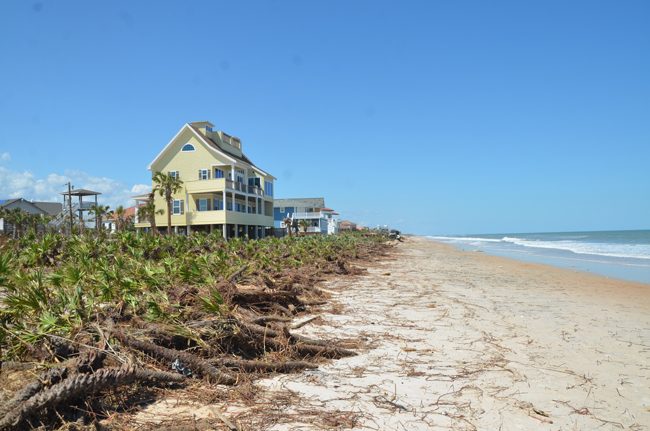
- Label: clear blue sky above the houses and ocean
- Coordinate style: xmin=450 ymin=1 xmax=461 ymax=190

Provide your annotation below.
xmin=0 ymin=0 xmax=650 ymax=235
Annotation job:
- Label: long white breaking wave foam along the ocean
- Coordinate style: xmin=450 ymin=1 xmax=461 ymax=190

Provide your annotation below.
xmin=429 ymin=236 xmax=650 ymax=260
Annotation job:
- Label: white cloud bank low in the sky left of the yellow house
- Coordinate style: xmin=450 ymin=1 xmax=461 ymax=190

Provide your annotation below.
xmin=0 ymin=165 xmax=151 ymax=208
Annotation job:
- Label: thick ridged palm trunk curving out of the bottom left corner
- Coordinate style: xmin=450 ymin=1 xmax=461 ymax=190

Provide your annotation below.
xmin=0 ymin=366 xmax=184 ymax=430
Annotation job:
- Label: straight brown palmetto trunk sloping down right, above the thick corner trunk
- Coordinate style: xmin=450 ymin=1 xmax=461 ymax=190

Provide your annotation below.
xmin=113 ymin=331 xmax=237 ymax=385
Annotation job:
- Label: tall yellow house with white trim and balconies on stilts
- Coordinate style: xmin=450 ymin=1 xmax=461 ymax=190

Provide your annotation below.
xmin=135 ymin=121 xmax=275 ymax=238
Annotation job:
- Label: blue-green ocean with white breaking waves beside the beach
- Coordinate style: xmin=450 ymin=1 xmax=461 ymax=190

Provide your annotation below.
xmin=428 ymin=230 xmax=650 ymax=284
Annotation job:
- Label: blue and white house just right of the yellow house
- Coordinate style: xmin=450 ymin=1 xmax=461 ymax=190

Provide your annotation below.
xmin=273 ymin=198 xmax=339 ymax=235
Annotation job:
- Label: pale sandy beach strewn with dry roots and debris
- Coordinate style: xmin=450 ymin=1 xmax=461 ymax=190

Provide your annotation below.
xmin=134 ymin=238 xmax=650 ymax=430
